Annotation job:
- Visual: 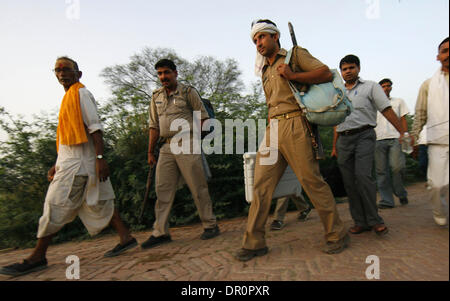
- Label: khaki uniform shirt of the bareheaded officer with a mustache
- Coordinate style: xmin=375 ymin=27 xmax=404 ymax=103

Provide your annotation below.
xmin=150 ymin=83 xmax=209 ymax=138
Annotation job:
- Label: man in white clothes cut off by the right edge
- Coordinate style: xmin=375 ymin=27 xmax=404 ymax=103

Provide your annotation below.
xmin=412 ymin=37 xmax=449 ymax=226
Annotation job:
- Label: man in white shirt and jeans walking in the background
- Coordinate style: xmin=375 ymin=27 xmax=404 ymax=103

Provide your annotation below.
xmin=375 ymin=78 xmax=409 ymax=209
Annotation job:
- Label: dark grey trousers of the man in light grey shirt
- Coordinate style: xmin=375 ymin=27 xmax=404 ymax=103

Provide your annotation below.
xmin=336 ymin=129 xmax=384 ymax=227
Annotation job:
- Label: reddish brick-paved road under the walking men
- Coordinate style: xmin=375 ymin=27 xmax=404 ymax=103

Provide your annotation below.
xmin=0 ymin=183 xmax=449 ymax=281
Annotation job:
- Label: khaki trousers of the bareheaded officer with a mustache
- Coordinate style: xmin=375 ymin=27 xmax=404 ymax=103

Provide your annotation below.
xmin=152 ymin=143 xmax=216 ymax=237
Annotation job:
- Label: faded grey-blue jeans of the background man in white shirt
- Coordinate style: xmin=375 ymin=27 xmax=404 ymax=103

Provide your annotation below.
xmin=375 ymin=139 xmax=408 ymax=207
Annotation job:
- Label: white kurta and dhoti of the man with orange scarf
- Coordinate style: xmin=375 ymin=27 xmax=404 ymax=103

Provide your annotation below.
xmin=37 ymin=88 xmax=115 ymax=238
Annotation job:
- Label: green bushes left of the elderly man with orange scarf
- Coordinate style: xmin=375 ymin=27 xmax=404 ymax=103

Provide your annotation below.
xmin=0 ymin=108 xmax=56 ymax=248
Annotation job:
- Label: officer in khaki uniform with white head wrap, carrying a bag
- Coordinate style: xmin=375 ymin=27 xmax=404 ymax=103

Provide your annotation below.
xmin=235 ymin=20 xmax=350 ymax=261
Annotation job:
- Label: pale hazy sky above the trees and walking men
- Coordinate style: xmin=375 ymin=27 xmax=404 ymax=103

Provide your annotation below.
xmin=0 ymin=0 xmax=449 ymax=140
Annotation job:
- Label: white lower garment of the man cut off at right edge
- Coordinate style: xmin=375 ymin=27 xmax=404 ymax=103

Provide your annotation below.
xmin=427 ymin=144 xmax=449 ymax=218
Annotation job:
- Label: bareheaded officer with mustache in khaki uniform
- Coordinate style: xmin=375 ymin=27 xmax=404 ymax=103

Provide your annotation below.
xmin=142 ymin=59 xmax=220 ymax=248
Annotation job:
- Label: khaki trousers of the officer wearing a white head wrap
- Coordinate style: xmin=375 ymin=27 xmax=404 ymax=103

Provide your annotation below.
xmin=243 ymin=116 xmax=347 ymax=250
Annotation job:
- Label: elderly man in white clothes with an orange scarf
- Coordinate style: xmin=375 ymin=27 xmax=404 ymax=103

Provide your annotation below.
xmin=0 ymin=57 xmax=137 ymax=276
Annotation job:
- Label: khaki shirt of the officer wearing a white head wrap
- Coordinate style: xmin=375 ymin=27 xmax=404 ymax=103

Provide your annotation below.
xmin=262 ymin=46 xmax=324 ymax=118
